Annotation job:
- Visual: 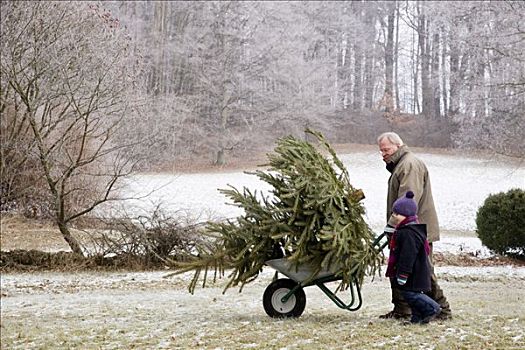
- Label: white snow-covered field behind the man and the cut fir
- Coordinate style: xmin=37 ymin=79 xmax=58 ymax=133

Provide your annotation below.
xmin=116 ymin=150 xmax=525 ymax=257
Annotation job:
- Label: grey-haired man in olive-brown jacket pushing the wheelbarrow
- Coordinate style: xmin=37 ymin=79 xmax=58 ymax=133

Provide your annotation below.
xmin=377 ymin=132 xmax=452 ymax=319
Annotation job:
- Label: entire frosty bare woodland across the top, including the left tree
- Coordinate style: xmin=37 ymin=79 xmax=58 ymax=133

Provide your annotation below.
xmin=0 ymin=0 xmax=525 ymax=241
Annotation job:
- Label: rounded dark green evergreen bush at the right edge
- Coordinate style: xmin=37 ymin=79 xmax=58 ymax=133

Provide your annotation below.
xmin=476 ymin=188 xmax=525 ymax=259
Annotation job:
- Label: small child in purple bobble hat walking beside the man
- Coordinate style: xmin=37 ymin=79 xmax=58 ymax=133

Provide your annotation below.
xmin=386 ymin=191 xmax=441 ymax=323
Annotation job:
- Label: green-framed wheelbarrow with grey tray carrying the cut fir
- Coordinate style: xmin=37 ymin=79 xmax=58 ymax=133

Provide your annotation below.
xmin=263 ymin=233 xmax=388 ymax=318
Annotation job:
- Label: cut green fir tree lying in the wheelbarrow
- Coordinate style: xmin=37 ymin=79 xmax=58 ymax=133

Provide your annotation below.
xmin=174 ymin=129 xmax=382 ymax=293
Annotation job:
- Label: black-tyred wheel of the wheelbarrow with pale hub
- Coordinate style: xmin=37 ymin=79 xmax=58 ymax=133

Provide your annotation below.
xmin=263 ymin=278 xmax=306 ymax=318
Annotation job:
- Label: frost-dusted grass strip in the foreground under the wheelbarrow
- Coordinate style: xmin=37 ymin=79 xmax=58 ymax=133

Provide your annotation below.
xmin=2 ymin=266 xmax=525 ymax=349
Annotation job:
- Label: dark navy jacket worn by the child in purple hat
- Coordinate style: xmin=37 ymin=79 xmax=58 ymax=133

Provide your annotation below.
xmin=387 ymin=224 xmax=430 ymax=292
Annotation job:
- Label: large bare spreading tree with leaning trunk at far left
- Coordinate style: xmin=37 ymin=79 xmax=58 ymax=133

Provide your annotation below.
xmin=0 ymin=1 xmax=139 ymax=254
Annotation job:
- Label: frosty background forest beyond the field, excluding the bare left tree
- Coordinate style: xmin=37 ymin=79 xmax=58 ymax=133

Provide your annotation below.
xmin=108 ymin=1 xmax=525 ymax=166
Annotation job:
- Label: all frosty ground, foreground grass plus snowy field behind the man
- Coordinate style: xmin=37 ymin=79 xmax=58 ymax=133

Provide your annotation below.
xmin=1 ymin=148 xmax=525 ymax=350
